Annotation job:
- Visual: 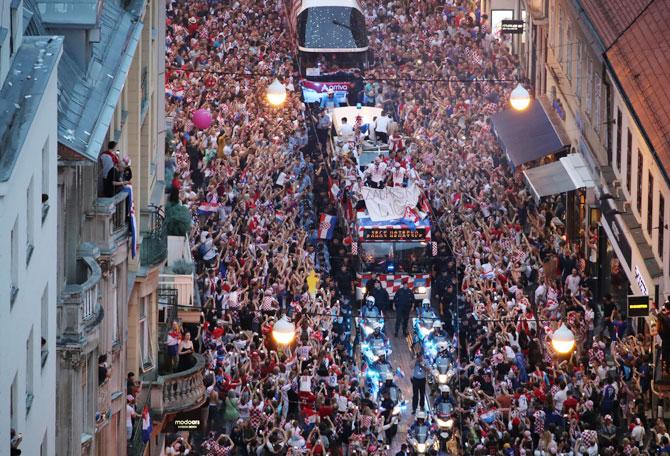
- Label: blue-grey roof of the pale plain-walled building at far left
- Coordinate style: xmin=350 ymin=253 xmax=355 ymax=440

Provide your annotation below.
xmin=0 ymin=36 xmax=63 ymax=182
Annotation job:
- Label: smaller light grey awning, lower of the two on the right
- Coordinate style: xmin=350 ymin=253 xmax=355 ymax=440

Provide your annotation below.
xmin=523 ymin=154 xmax=595 ymax=200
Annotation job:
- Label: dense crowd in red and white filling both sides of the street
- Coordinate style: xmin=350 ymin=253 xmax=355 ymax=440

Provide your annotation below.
xmin=160 ymin=0 xmax=670 ymax=455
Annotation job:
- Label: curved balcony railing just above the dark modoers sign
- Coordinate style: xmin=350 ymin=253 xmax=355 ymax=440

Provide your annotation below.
xmin=151 ymin=353 xmax=205 ymax=416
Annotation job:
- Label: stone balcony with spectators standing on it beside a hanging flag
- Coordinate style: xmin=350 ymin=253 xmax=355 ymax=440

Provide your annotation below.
xmin=86 ymin=192 xmax=128 ymax=255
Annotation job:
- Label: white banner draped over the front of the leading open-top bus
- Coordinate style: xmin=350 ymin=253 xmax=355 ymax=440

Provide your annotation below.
xmin=361 ymin=185 xmax=421 ymax=222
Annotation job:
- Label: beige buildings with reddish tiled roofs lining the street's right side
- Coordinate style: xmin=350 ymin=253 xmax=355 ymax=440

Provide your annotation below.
xmin=545 ymin=0 xmax=670 ymax=303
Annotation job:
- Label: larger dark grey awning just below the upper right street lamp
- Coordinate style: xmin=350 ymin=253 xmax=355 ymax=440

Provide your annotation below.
xmin=491 ymin=100 xmax=566 ymax=166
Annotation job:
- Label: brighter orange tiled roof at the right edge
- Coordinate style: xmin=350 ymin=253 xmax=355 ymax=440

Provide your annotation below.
xmin=606 ymin=0 xmax=670 ymax=174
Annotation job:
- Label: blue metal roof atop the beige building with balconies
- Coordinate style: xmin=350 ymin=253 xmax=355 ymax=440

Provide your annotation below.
xmin=27 ymin=0 xmax=146 ymax=160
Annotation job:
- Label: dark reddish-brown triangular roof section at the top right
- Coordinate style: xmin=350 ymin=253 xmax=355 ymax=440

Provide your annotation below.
xmin=579 ymin=0 xmax=650 ymax=48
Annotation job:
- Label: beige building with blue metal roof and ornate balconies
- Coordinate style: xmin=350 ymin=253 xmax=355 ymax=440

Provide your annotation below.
xmin=26 ymin=0 xmax=167 ymax=455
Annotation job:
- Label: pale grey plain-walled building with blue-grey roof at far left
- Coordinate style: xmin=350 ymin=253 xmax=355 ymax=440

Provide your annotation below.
xmin=0 ymin=0 xmax=63 ymax=455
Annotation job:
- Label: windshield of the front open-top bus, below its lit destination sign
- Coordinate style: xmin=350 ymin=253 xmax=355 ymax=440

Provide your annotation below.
xmin=358 ymin=242 xmax=427 ymax=274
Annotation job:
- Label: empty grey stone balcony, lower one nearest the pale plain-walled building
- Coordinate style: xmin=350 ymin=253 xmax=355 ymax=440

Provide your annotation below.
xmin=58 ymin=243 xmax=103 ymax=344
